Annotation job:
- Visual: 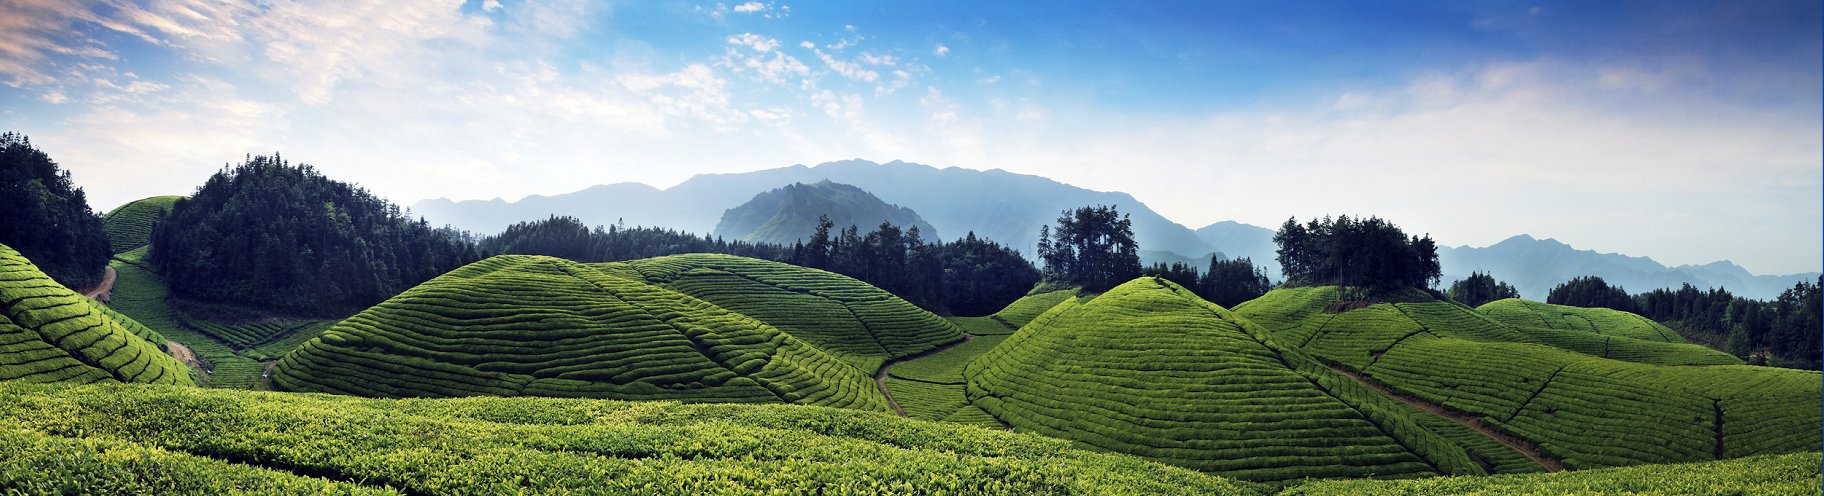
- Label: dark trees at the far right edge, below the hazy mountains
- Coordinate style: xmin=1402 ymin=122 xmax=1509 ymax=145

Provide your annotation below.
xmin=1634 ymin=279 xmax=1824 ymax=370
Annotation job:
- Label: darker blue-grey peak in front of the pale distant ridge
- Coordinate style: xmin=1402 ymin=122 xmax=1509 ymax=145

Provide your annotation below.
xmin=713 ymin=181 xmax=941 ymax=244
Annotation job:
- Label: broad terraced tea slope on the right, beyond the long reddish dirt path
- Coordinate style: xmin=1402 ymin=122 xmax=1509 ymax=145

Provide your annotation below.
xmin=1237 ymin=288 xmax=1824 ymax=469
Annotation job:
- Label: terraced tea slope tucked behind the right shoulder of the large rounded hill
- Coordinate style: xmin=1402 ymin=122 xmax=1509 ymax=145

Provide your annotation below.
xmin=598 ymin=253 xmax=963 ymax=374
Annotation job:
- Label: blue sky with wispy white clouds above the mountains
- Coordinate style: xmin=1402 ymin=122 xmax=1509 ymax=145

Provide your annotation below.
xmin=0 ymin=0 xmax=1824 ymax=274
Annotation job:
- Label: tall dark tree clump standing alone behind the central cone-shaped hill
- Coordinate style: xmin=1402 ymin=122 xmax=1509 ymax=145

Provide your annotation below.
xmin=1038 ymin=206 xmax=1140 ymax=292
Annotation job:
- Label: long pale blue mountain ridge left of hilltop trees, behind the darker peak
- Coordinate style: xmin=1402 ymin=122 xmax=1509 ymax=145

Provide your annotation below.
xmin=412 ymin=159 xmax=1215 ymax=255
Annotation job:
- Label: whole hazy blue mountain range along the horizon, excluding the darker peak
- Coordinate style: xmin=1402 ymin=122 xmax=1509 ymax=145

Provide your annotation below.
xmin=412 ymin=159 xmax=1819 ymax=299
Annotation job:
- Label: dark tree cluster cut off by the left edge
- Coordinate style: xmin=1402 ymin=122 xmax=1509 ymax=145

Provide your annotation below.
xmin=0 ymin=133 xmax=111 ymax=288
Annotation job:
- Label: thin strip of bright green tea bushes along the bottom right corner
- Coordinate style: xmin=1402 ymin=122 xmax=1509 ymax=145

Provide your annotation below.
xmin=1282 ymin=452 xmax=1824 ymax=496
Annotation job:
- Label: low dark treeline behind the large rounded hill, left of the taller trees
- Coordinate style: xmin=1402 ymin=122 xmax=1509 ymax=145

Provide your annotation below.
xmin=478 ymin=215 xmax=792 ymax=263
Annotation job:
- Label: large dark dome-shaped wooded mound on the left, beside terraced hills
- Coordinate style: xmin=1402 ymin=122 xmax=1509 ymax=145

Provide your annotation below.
xmin=150 ymin=155 xmax=476 ymax=315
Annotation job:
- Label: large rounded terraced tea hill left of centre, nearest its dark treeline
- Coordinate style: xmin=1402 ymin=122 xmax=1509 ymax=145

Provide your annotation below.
xmin=274 ymin=255 xmax=886 ymax=410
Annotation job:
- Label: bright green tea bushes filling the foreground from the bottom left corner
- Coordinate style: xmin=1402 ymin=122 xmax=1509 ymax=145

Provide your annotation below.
xmin=0 ymin=383 xmax=1264 ymax=494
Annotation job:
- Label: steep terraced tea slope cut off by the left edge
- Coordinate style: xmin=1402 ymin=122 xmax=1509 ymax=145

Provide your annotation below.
xmin=0 ymin=244 xmax=193 ymax=385
